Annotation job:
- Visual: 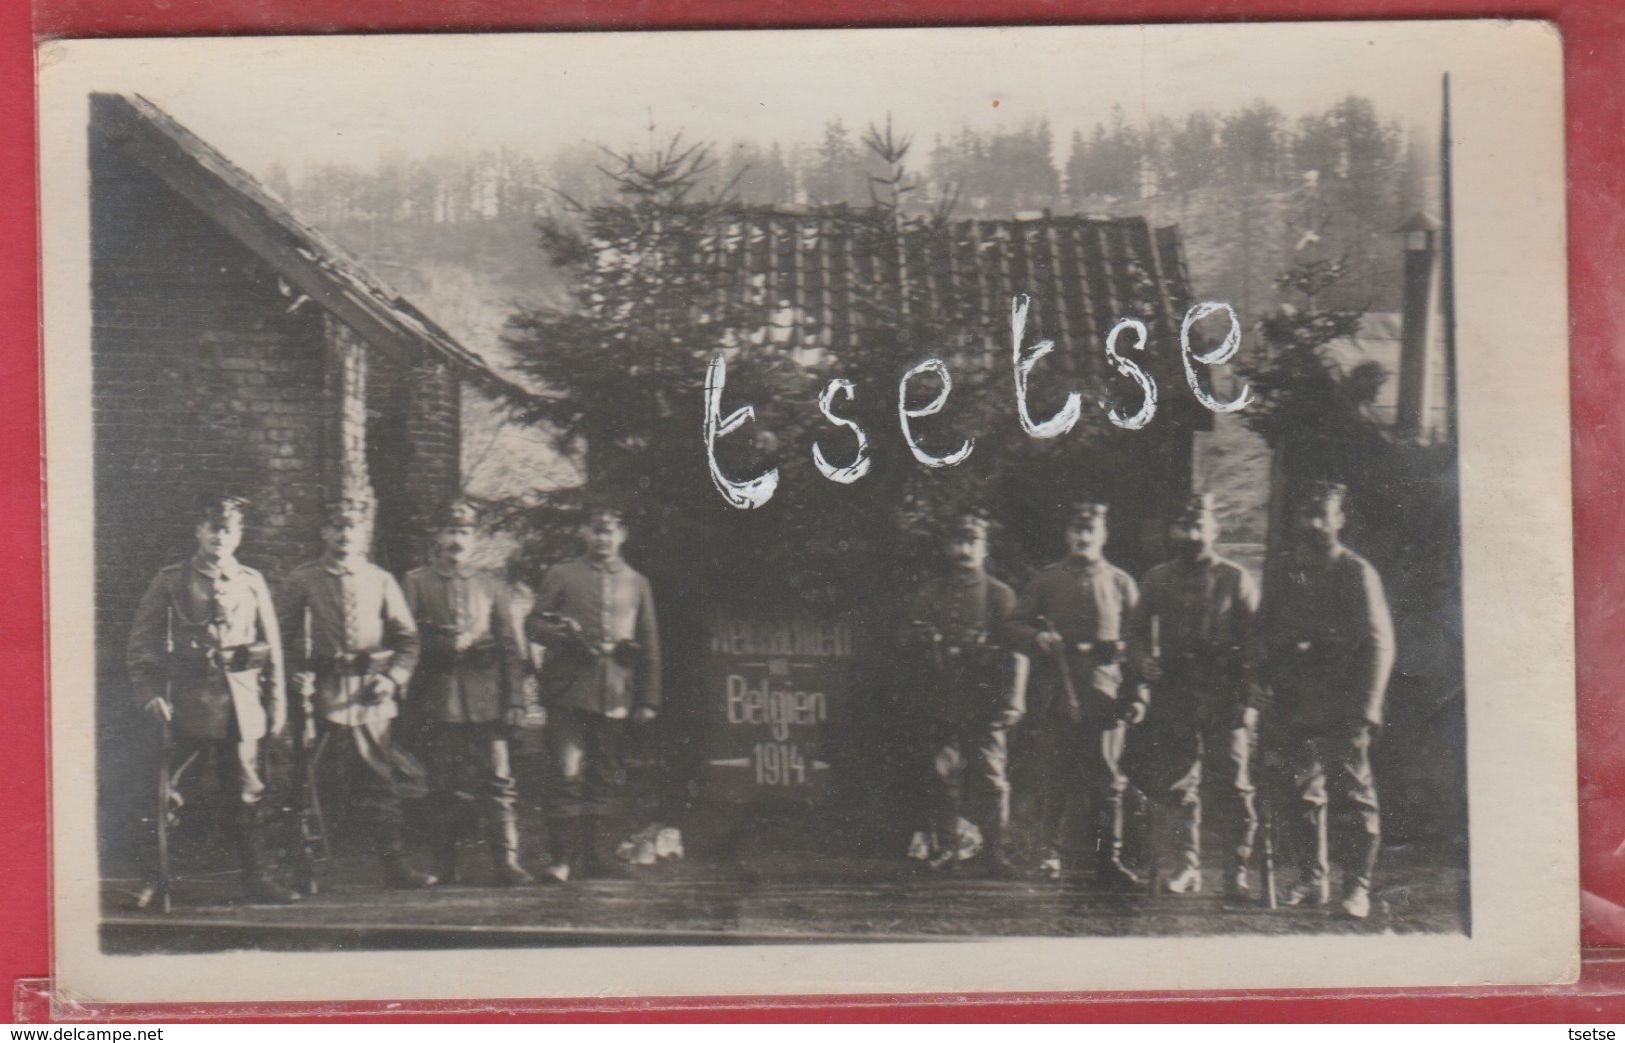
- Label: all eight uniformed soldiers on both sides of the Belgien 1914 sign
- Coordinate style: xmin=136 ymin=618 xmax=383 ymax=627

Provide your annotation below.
xmin=128 ymin=484 xmax=1394 ymax=918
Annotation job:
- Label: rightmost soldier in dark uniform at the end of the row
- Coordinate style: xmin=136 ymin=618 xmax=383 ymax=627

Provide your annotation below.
xmin=1263 ymin=483 xmax=1394 ymax=920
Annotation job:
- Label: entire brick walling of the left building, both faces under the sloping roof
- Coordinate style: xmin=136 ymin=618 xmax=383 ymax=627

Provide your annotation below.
xmin=88 ymin=132 xmax=460 ymax=872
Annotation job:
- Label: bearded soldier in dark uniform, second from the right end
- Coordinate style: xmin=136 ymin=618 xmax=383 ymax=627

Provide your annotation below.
xmin=1129 ymin=492 xmax=1258 ymax=898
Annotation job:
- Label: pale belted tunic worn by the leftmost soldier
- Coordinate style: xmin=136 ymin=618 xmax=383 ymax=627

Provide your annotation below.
xmin=127 ymin=557 xmax=286 ymax=742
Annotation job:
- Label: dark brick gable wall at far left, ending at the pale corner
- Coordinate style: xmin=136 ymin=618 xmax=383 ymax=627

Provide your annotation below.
xmin=91 ymin=135 xmax=327 ymax=673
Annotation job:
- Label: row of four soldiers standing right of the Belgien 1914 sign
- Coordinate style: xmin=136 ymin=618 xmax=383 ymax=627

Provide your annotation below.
xmin=900 ymin=483 xmax=1394 ymax=920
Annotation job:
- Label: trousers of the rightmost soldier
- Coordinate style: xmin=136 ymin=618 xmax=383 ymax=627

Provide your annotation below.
xmin=1282 ymin=721 xmax=1383 ymax=887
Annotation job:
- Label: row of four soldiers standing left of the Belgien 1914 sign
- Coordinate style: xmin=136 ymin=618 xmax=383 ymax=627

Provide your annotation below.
xmin=127 ymin=497 xmax=660 ymax=907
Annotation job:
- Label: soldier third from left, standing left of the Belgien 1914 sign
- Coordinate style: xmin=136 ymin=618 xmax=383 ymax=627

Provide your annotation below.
xmin=406 ymin=500 xmax=533 ymax=887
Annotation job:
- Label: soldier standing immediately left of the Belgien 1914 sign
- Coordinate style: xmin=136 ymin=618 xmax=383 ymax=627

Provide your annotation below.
xmin=528 ymin=505 xmax=660 ymax=884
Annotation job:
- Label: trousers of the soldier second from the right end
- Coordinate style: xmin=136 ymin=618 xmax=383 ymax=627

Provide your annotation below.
xmin=1134 ymin=715 xmax=1258 ymax=871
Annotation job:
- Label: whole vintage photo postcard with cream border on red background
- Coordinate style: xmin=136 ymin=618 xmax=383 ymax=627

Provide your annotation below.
xmin=39 ymin=21 xmax=1578 ymax=1001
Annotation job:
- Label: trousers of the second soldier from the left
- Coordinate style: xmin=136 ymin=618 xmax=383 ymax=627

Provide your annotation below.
xmin=312 ymin=718 xmax=427 ymax=858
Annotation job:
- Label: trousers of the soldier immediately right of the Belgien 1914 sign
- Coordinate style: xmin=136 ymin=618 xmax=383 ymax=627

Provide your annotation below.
xmin=926 ymin=721 xmax=1011 ymax=855
